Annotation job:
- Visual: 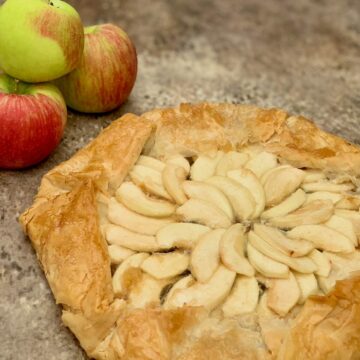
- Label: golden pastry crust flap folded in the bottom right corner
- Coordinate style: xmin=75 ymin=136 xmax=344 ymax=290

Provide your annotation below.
xmin=278 ymin=276 xmax=360 ymax=360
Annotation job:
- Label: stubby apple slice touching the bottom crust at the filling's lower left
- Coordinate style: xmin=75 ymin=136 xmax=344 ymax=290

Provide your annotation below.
xmin=128 ymin=274 xmax=171 ymax=309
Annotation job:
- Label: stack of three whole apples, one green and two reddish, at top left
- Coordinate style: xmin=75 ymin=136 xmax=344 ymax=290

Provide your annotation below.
xmin=0 ymin=0 xmax=137 ymax=169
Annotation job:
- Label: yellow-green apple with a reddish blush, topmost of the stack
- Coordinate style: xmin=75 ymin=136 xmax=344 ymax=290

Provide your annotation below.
xmin=0 ymin=0 xmax=84 ymax=82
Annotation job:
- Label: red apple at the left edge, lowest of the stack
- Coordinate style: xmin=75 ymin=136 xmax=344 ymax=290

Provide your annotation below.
xmin=0 ymin=74 xmax=67 ymax=169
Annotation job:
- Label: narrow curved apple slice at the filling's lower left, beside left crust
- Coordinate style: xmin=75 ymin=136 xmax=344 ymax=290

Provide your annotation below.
xmin=112 ymin=253 xmax=149 ymax=296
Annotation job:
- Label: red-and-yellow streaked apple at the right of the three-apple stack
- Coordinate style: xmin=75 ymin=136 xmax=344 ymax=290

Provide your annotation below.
xmin=55 ymin=24 xmax=137 ymax=113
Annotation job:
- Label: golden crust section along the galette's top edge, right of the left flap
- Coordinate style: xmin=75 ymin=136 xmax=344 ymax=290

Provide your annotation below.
xmin=143 ymin=104 xmax=287 ymax=157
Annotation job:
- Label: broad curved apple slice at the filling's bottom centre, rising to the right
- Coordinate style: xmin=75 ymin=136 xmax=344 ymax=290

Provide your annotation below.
xmin=167 ymin=265 xmax=236 ymax=311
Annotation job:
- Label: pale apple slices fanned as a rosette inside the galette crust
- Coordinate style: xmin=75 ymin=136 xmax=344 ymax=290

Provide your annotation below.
xmin=98 ymin=147 xmax=360 ymax=317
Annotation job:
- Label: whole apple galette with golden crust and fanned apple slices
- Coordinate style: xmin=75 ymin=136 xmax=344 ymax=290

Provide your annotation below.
xmin=21 ymin=104 xmax=360 ymax=360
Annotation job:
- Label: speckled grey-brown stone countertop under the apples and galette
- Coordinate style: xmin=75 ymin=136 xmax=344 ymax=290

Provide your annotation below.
xmin=0 ymin=0 xmax=360 ymax=360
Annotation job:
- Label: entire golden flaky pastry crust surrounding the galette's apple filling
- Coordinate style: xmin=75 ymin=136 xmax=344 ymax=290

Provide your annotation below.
xmin=20 ymin=103 xmax=360 ymax=360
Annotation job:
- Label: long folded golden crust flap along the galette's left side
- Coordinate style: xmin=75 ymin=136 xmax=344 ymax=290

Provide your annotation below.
xmin=20 ymin=115 xmax=152 ymax=352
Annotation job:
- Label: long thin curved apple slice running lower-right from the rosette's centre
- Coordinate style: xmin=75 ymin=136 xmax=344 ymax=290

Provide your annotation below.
xmin=248 ymin=231 xmax=317 ymax=274
